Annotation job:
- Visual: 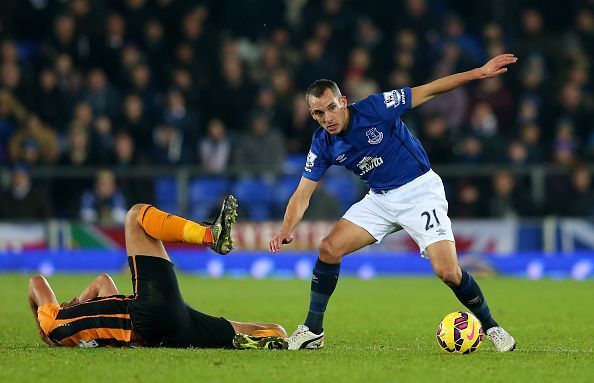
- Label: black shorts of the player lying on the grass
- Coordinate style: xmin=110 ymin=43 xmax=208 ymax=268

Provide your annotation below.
xmin=128 ymin=255 xmax=235 ymax=348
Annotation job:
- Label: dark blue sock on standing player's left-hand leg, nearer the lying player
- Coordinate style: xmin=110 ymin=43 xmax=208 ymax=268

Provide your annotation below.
xmin=304 ymin=258 xmax=340 ymax=334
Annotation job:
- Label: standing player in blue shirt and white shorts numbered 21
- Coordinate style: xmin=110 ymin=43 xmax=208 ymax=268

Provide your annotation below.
xmin=269 ymin=54 xmax=517 ymax=352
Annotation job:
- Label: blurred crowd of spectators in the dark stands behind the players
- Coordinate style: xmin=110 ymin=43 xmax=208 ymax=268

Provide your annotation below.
xmin=0 ymin=0 xmax=594 ymax=222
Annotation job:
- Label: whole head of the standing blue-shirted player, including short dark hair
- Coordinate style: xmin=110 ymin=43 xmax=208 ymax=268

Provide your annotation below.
xmin=305 ymin=80 xmax=348 ymax=134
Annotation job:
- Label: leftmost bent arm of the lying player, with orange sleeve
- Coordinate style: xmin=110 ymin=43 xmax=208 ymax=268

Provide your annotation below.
xmin=29 ymin=275 xmax=60 ymax=346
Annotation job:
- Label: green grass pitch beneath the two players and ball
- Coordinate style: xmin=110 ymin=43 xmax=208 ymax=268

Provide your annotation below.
xmin=0 ymin=274 xmax=594 ymax=383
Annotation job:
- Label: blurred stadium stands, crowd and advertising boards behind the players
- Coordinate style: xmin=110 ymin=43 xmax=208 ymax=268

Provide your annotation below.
xmin=0 ymin=0 xmax=594 ymax=279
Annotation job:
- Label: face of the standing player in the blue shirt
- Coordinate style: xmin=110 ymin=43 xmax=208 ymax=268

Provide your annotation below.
xmin=309 ymin=89 xmax=348 ymax=134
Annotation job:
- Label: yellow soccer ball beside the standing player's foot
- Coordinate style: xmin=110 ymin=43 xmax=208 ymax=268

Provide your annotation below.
xmin=436 ymin=311 xmax=483 ymax=354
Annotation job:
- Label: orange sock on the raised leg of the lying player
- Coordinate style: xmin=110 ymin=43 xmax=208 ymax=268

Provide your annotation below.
xmin=138 ymin=205 xmax=214 ymax=246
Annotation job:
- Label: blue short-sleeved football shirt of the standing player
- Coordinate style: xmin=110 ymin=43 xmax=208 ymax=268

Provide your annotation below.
xmin=303 ymin=87 xmax=431 ymax=191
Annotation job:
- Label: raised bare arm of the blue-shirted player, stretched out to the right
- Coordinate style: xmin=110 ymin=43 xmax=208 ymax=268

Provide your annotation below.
xmin=411 ymin=53 xmax=518 ymax=108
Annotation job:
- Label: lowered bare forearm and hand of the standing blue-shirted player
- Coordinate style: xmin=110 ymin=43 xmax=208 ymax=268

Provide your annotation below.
xmin=268 ymin=177 xmax=318 ymax=253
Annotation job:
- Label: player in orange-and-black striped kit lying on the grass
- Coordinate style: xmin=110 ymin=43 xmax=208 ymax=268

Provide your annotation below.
xmin=29 ymin=196 xmax=287 ymax=349
